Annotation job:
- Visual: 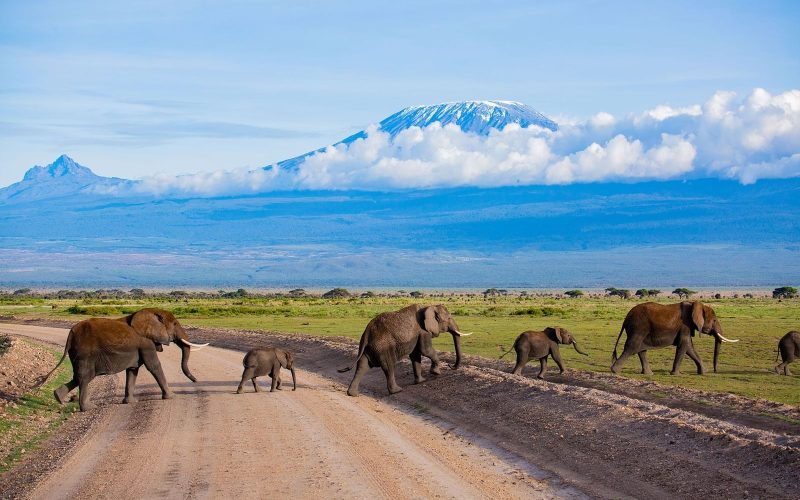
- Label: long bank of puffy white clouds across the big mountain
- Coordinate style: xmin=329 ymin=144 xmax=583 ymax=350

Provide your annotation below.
xmin=137 ymin=89 xmax=800 ymax=195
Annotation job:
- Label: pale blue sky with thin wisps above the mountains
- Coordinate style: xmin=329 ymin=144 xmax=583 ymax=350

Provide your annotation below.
xmin=0 ymin=0 xmax=800 ymax=186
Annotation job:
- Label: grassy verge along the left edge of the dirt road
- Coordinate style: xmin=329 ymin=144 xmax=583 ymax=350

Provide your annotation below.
xmin=0 ymin=344 xmax=78 ymax=474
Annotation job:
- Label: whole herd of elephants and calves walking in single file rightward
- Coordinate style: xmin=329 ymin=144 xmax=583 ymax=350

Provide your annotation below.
xmin=39 ymin=302 xmax=800 ymax=411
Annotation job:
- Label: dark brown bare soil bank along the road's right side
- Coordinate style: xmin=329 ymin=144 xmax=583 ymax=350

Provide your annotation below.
xmin=189 ymin=329 xmax=800 ymax=498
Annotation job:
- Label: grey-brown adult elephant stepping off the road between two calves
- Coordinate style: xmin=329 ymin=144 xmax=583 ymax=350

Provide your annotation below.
xmin=338 ymin=304 xmax=472 ymax=396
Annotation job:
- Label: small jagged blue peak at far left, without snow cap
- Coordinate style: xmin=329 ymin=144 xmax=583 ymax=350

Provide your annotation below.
xmin=0 ymin=155 xmax=132 ymax=203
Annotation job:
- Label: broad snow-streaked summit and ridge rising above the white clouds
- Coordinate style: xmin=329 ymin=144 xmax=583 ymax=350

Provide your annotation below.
xmin=276 ymin=101 xmax=558 ymax=170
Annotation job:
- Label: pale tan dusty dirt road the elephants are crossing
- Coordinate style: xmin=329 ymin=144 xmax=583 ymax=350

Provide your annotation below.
xmin=0 ymin=324 xmax=583 ymax=500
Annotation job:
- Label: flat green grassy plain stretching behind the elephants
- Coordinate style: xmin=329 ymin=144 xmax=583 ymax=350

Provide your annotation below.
xmin=0 ymin=293 xmax=800 ymax=404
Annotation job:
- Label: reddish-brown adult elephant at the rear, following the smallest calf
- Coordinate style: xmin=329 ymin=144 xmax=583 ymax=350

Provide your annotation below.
xmin=38 ymin=308 xmax=208 ymax=411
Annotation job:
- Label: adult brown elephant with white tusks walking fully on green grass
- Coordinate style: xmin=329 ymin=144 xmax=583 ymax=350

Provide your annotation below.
xmin=611 ymin=301 xmax=738 ymax=375
